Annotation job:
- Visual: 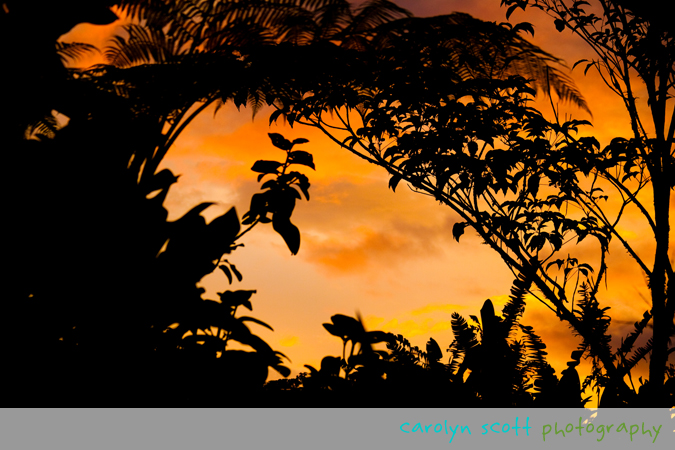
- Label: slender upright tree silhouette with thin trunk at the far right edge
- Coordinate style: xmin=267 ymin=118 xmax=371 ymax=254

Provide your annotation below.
xmin=502 ymin=0 xmax=675 ymax=404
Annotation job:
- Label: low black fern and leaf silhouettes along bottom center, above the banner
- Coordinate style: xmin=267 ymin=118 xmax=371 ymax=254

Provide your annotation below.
xmin=263 ymin=278 xmax=590 ymax=408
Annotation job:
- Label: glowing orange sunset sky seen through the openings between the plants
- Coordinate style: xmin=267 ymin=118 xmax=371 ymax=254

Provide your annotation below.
xmin=62 ymin=0 xmax=672 ymax=396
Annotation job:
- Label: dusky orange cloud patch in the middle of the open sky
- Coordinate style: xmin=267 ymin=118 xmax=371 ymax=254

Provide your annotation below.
xmin=298 ymin=187 xmax=462 ymax=275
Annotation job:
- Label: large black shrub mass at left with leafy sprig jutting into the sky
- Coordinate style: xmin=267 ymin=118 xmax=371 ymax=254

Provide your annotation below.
xmin=4 ymin=87 xmax=313 ymax=406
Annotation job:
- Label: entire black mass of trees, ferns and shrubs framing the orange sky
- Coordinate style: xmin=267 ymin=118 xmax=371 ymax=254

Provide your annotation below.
xmin=0 ymin=0 xmax=675 ymax=407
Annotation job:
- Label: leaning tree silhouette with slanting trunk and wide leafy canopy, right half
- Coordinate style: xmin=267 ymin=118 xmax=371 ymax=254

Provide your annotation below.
xmin=258 ymin=3 xmax=674 ymax=405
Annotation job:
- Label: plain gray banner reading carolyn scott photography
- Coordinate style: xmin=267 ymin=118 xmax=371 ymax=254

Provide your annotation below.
xmin=0 ymin=409 xmax=675 ymax=450
